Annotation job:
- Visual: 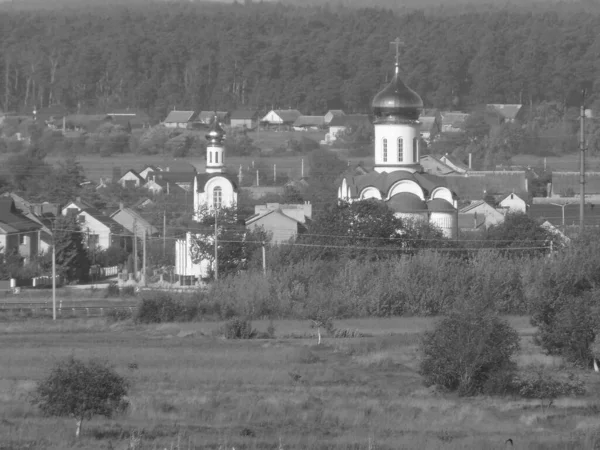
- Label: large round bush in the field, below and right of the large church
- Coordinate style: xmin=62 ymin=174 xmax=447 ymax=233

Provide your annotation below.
xmin=420 ymin=309 xmax=519 ymax=395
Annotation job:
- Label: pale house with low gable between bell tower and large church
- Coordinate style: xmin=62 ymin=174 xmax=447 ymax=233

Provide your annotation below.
xmin=246 ymin=202 xmax=312 ymax=244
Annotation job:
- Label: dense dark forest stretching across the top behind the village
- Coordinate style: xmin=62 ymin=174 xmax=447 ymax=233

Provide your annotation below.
xmin=0 ymin=2 xmax=600 ymax=117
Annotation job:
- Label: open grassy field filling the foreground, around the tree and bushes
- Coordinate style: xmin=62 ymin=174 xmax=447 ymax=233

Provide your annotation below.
xmin=0 ymin=318 xmax=600 ymax=450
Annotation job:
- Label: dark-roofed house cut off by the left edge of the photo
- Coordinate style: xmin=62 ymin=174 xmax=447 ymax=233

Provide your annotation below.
xmin=0 ymin=197 xmax=42 ymax=264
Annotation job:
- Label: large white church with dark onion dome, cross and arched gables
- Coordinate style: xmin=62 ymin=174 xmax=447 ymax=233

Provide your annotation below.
xmin=338 ymin=43 xmax=458 ymax=238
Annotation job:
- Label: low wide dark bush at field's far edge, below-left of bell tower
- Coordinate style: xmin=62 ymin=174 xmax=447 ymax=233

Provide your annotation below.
xmin=135 ymin=292 xmax=199 ymax=323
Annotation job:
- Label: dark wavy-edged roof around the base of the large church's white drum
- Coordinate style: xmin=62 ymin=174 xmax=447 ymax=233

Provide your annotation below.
xmin=346 ymin=170 xmax=452 ymax=198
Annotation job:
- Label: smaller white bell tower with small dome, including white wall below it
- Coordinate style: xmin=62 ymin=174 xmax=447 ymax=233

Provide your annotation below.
xmin=175 ymin=117 xmax=238 ymax=279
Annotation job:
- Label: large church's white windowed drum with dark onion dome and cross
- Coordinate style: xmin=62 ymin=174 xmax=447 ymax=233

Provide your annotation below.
xmin=371 ymin=39 xmax=423 ymax=173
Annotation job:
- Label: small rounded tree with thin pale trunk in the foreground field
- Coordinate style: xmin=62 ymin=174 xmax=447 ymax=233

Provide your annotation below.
xmin=33 ymin=356 xmax=129 ymax=437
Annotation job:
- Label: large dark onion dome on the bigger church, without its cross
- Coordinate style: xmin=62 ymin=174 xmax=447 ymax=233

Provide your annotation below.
xmin=371 ymin=70 xmax=423 ymax=120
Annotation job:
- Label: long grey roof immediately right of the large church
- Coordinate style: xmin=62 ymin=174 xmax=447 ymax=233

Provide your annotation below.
xmin=444 ymin=171 xmax=528 ymax=200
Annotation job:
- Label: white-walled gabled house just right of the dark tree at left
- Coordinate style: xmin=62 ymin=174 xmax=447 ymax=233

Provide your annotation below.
xmin=61 ymin=197 xmax=125 ymax=249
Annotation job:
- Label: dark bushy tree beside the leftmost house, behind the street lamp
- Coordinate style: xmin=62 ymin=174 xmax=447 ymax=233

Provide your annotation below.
xmin=53 ymin=214 xmax=90 ymax=281
